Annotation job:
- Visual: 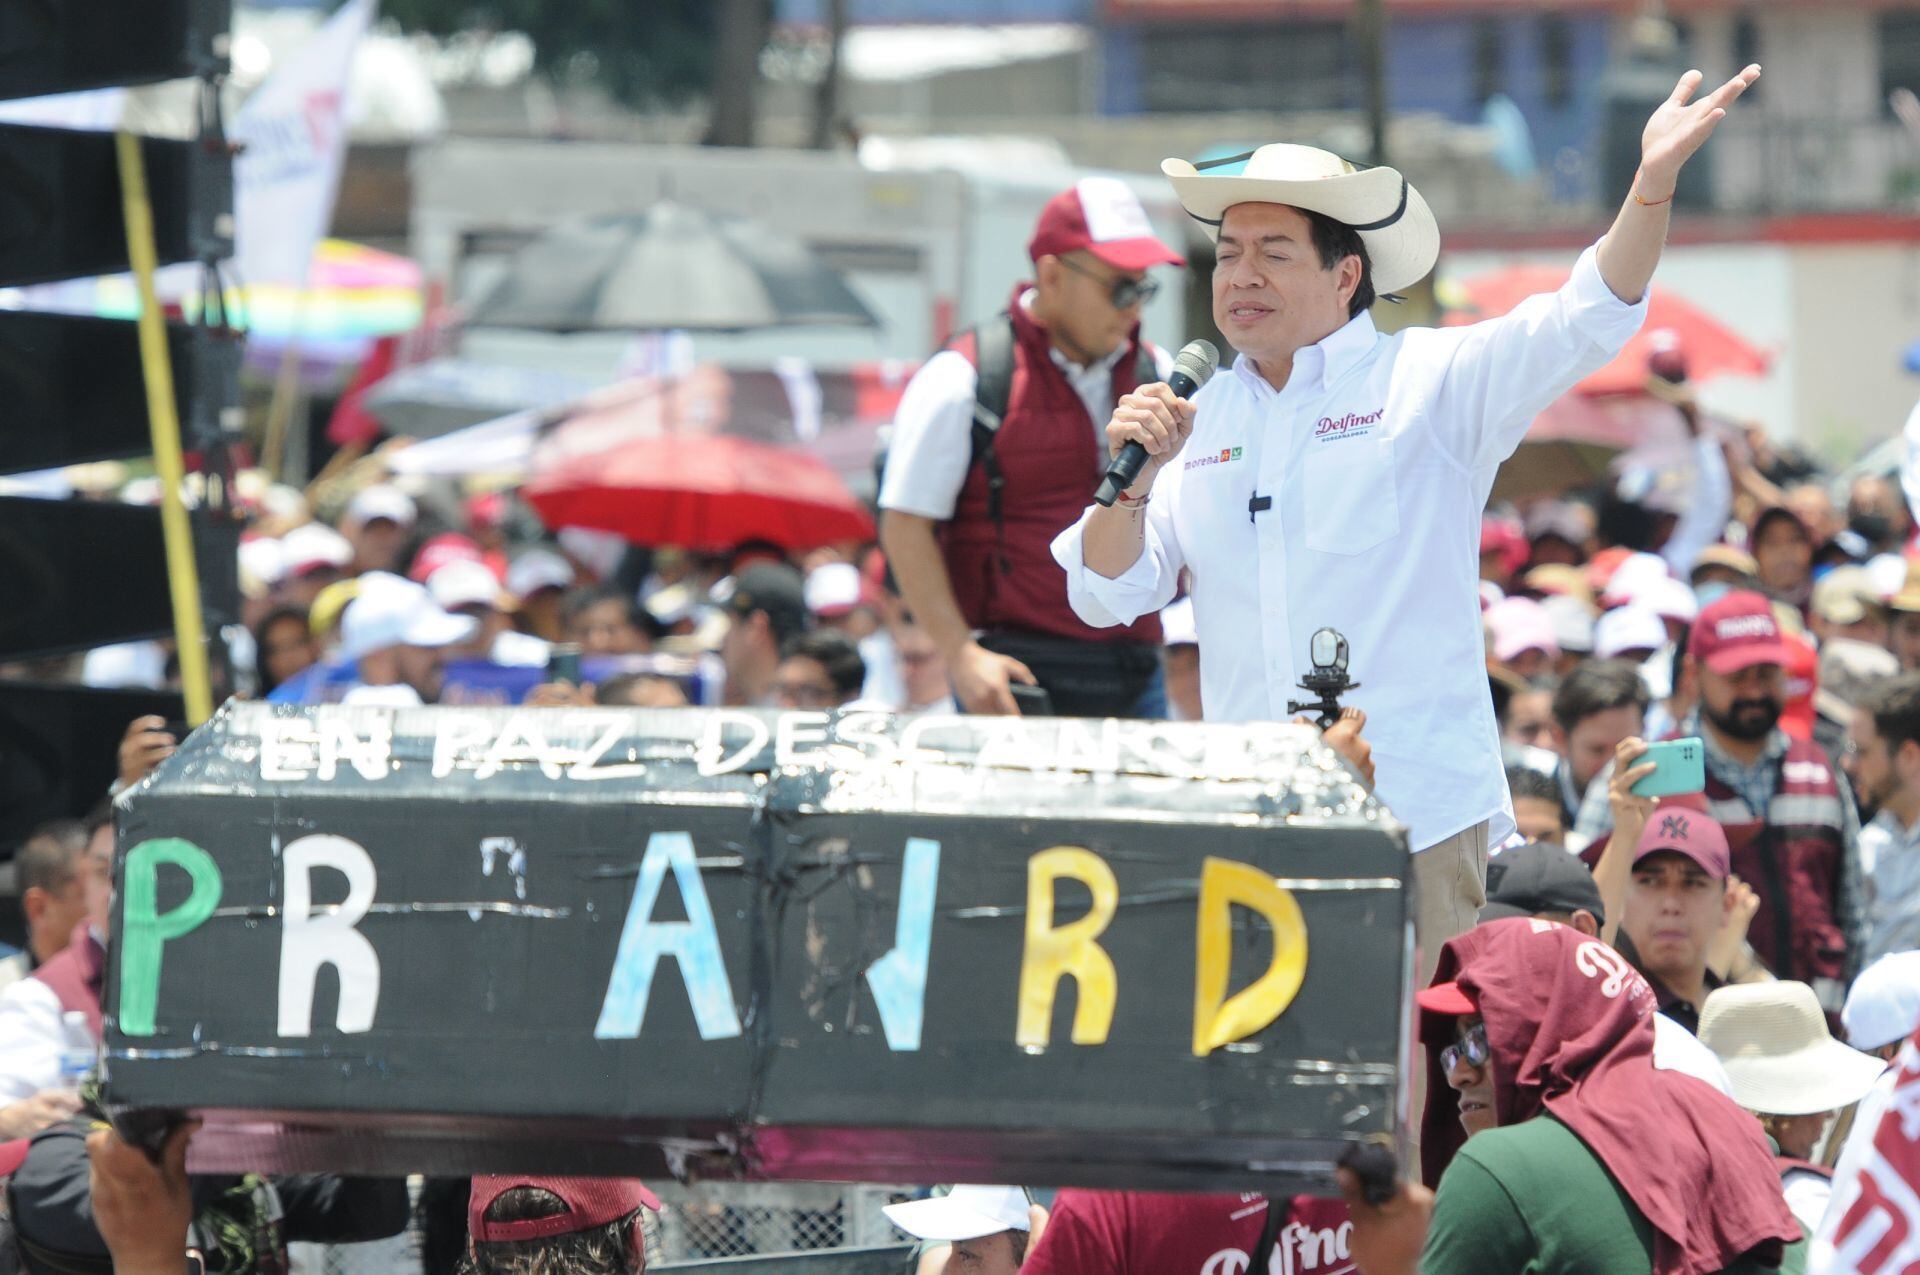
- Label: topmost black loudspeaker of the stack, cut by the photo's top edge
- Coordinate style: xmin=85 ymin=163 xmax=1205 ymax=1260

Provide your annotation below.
xmin=0 ymin=0 xmax=232 ymax=98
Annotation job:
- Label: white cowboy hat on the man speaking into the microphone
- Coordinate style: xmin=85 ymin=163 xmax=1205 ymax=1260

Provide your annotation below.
xmin=1160 ymin=142 xmax=1440 ymax=292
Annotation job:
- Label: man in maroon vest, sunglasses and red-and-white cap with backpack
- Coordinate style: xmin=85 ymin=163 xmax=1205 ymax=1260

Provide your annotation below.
xmin=879 ymin=177 xmax=1185 ymax=716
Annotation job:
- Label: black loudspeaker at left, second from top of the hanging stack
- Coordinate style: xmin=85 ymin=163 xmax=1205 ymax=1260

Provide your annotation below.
xmin=0 ymin=122 xmax=234 ymax=284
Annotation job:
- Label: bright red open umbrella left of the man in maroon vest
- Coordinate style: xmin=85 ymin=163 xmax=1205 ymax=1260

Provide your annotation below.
xmin=522 ymin=434 xmax=874 ymax=551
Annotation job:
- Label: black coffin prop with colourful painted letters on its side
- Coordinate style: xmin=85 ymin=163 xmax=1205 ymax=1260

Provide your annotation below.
xmin=108 ymin=705 xmax=1409 ymax=1192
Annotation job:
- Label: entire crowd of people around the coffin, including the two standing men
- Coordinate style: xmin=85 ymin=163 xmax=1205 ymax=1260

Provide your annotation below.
xmin=0 ymin=54 xmax=1920 ymax=1275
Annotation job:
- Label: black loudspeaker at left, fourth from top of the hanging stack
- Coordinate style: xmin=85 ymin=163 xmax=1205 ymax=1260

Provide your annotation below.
xmin=0 ymin=497 xmax=240 ymax=659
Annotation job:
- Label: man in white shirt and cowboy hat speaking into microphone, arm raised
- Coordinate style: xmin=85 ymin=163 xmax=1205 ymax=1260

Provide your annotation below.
xmin=1054 ymin=67 xmax=1759 ymax=968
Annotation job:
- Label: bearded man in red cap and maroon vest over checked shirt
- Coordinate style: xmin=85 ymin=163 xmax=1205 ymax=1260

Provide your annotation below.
xmin=1596 ymin=589 xmax=1864 ymax=1014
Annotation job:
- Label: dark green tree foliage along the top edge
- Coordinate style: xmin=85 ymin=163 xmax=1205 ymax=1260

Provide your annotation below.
xmin=380 ymin=0 xmax=726 ymax=106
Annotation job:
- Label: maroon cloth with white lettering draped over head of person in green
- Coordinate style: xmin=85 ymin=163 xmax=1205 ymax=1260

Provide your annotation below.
xmin=1421 ymin=916 xmax=1799 ymax=1275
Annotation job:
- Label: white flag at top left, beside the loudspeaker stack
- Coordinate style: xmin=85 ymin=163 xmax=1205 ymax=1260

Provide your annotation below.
xmin=230 ymin=0 xmax=374 ymax=288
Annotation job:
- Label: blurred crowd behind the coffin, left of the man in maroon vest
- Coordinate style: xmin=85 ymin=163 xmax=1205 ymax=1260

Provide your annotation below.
xmin=56 ymin=480 xmax=952 ymax=725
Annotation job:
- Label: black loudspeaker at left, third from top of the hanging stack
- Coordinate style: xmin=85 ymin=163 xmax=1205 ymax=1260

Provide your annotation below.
xmin=0 ymin=311 xmax=240 ymax=474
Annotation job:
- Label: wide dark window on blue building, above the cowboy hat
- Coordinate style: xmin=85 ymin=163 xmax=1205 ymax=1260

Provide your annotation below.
xmin=1140 ymin=21 xmax=1361 ymax=113
